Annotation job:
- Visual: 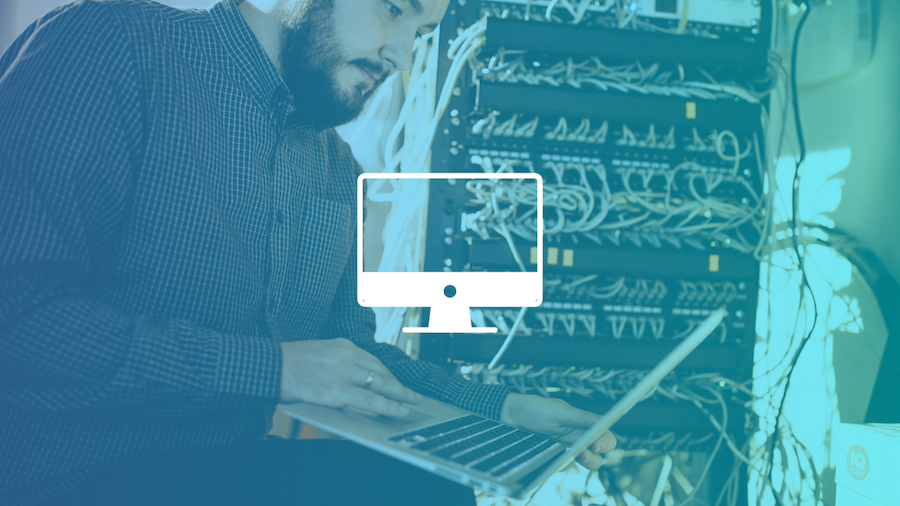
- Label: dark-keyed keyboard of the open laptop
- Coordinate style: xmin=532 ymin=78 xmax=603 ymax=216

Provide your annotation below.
xmin=391 ymin=415 xmax=560 ymax=479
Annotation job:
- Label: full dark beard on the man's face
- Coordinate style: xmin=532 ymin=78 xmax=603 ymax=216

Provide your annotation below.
xmin=278 ymin=0 xmax=388 ymax=131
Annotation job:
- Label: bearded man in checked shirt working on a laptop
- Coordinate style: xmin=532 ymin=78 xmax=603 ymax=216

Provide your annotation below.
xmin=0 ymin=0 xmax=615 ymax=505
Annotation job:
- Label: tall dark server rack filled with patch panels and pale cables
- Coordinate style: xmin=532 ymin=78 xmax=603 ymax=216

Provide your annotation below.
xmin=420 ymin=0 xmax=772 ymax=504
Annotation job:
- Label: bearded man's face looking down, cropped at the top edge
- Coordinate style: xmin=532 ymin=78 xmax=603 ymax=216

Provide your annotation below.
xmin=275 ymin=0 xmax=450 ymax=129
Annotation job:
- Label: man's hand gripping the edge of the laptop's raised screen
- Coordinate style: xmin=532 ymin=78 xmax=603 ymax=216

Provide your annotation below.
xmin=500 ymin=393 xmax=616 ymax=469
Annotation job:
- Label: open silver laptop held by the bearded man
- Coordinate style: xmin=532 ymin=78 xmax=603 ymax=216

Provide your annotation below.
xmin=278 ymin=308 xmax=726 ymax=498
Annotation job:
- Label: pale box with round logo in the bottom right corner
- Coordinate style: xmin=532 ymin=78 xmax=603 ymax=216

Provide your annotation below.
xmin=832 ymin=423 xmax=900 ymax=506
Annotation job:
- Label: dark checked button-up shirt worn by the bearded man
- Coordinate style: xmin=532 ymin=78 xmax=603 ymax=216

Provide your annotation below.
xmin=0 ymin=0 xmax=508 ymax=504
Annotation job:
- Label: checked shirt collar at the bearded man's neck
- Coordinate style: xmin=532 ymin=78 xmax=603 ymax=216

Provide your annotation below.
xmin=209 ymin=0 xmax=290 ymax=109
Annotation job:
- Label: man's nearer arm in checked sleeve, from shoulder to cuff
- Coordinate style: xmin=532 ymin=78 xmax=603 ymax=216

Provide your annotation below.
xmin=0 ymin=2 xmax=281 ymax=418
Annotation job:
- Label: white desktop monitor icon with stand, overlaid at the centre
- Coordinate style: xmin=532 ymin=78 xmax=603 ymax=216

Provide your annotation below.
xmin=357 ymin=173 xmax=543 ymax=333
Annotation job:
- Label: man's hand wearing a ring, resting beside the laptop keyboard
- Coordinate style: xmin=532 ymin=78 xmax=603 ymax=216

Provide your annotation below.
xmin=279 ymin=338 xmax=422 ymax=417
